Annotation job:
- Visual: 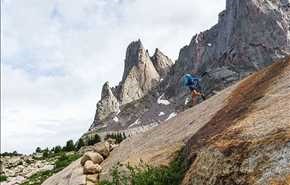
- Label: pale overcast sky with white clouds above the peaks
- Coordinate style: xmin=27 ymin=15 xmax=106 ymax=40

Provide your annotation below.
xmin=1 ymin=0 xmax=225 ymax=153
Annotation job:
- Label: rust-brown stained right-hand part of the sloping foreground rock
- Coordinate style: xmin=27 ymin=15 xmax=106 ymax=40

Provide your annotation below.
xmin=182 ymin=58 xmax=290 ymax=185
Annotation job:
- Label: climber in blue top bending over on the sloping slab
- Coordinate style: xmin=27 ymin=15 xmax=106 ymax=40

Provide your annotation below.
xmin=181 ymin=74 xmax=205 ymax=102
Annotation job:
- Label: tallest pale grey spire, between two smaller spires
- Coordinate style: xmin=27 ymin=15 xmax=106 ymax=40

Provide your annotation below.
xmin=118 ymin=40 xmax=160 ymax=104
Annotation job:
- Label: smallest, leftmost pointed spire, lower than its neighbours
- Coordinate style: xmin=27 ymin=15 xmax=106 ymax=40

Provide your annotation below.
xmin=94 ymin=82 xmax=119 ymax=124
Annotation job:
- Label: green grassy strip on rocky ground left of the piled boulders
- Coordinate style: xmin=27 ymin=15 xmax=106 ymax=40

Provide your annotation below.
xmin=21 ymin=152 xmax=80 ymax=185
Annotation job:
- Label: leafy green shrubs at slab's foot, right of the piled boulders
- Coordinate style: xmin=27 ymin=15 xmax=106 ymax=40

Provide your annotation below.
xmin=100 ymin=152 xmax=186 ymax=185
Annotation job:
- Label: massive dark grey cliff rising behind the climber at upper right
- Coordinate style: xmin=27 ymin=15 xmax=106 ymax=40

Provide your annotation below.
xmin=168 ymin=0 xmax=290 ymax=96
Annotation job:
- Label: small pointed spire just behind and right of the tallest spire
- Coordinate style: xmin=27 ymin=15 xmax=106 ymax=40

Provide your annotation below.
xmin=151 ymin=48 xmax=173 ymax=78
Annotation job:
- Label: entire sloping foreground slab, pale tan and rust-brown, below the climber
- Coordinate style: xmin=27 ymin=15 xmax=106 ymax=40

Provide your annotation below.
xmin=100 ymin=59 xmax=290 ymax=182
